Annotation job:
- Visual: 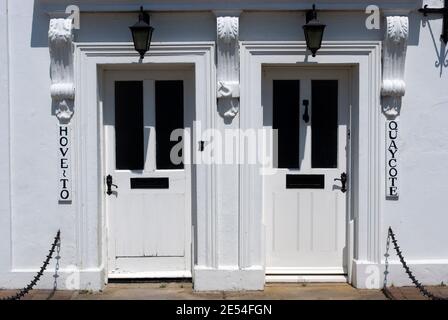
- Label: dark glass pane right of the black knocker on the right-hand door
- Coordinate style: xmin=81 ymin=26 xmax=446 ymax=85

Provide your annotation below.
xmin=311 ymin=80 xmax=338 ymax=168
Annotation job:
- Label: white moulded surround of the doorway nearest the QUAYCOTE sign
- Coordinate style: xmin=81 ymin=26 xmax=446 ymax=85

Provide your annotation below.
xmin=240 ymin=41 xmax=384 ymax=287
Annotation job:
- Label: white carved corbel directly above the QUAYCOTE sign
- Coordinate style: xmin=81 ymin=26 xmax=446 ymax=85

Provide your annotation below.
xmin=381 ymin=16 xmax=409 ymax=117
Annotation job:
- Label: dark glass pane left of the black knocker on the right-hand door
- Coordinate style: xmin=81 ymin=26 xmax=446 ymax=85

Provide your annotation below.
xmin=273 ymin=80 xmax=300 ymax=169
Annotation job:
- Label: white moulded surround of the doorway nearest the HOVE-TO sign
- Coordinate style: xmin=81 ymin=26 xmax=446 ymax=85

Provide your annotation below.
xmin=72 ymin=42 xmax=216 ymax=283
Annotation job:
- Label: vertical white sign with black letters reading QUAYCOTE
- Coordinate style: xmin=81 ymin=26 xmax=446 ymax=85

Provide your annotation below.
xmin=386 ymin=120 xmax=400 ymax=200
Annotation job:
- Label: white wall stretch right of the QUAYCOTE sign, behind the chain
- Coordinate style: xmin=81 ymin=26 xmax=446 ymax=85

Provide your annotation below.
xmin=382 ymin=9 xmax=448 ymax=285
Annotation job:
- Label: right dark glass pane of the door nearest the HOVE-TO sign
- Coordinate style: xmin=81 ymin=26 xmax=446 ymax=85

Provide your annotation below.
xmin=156 ymin=81 xmax=184 ymax=169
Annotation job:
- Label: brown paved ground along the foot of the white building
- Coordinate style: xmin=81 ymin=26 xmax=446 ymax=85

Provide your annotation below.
xmin=0 ymin=283 xmax=448 ymax=300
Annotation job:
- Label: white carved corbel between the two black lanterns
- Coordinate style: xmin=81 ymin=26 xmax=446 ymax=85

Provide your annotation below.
xmin=216 ymin=16 xmax=240 ymax=121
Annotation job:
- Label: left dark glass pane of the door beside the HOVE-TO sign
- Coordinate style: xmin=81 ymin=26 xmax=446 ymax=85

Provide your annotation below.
xmin=115 ymin=81 xmax=144 ymax=170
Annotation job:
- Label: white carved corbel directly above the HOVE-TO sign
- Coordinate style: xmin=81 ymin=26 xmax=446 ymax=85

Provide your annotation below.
xmin=48 ymin=19 xmax=75 ymax=123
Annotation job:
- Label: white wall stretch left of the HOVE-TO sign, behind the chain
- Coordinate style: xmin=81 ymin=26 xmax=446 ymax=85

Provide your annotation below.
xmin=0 ymin=1 xmax=77 ymax=287
